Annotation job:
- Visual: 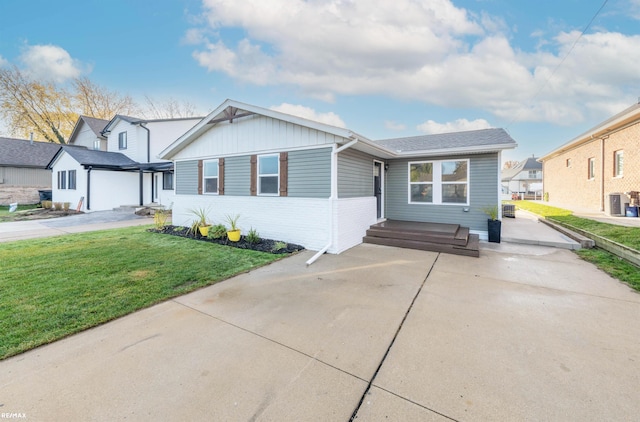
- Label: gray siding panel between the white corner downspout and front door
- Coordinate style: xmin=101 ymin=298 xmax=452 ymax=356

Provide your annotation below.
xmin=338 ymin=149 xmax=374 ymax=198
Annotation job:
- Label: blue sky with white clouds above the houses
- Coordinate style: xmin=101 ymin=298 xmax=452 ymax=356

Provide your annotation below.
xmin=0 ymin=0 xmax=640 ymax=160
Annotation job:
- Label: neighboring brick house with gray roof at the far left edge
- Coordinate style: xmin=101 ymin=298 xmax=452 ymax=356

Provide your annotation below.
xmin=0 ymin=138 xmax=61 ymax=205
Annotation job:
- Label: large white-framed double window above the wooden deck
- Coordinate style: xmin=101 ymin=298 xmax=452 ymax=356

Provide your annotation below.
xmin=409 ymin=160 xmax=469 ymax=205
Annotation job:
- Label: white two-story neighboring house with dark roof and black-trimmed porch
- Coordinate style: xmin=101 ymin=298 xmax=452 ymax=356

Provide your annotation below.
xmin=49 ymin=115 xmax=201 ymax=211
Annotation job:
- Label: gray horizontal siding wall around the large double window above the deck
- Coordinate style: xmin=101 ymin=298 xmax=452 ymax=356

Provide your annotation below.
xmin=385 ymin=153 xmax=500 ymax=232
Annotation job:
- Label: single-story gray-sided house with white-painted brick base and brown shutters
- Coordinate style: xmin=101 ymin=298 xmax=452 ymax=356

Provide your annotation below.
xmin=160 ymin=100 xmax=516 ymax=253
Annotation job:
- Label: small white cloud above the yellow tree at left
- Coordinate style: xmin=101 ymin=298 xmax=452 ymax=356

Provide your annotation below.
xmin=20 ymin=44 xmax=89 ymax=82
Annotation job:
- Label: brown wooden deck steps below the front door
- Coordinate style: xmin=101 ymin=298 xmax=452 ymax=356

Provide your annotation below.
xmin=362 ymin=220 xmax=480 ymax=257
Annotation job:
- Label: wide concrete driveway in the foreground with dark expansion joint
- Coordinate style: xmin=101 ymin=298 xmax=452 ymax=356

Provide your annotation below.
xmin=0 ymin=244 xmax=640 ymax=421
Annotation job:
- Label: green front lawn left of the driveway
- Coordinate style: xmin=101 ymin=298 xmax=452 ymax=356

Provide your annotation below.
xmin=0 ymin=227 xmax=282 ymax=359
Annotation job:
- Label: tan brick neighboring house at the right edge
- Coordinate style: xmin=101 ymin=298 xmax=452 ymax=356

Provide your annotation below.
xmin=540 ymin=103 xmax=640 ymax=211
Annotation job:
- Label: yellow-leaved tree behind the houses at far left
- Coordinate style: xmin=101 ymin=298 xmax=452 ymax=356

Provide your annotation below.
xmin=0 ymin=66 xmax=78 ymax=144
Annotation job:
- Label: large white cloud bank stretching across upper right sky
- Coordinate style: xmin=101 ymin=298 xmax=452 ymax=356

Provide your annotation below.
xmin=190 ymin=0 xmax=640 ymax=124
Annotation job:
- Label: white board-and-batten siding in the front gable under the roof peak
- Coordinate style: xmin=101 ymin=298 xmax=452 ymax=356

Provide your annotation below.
xmin=171 ymin=115 xmax=349 ymax=160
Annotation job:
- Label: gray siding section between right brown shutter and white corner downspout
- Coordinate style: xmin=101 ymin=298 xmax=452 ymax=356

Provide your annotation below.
xmin=287 ymin=148 xmax=331 ymax=198
